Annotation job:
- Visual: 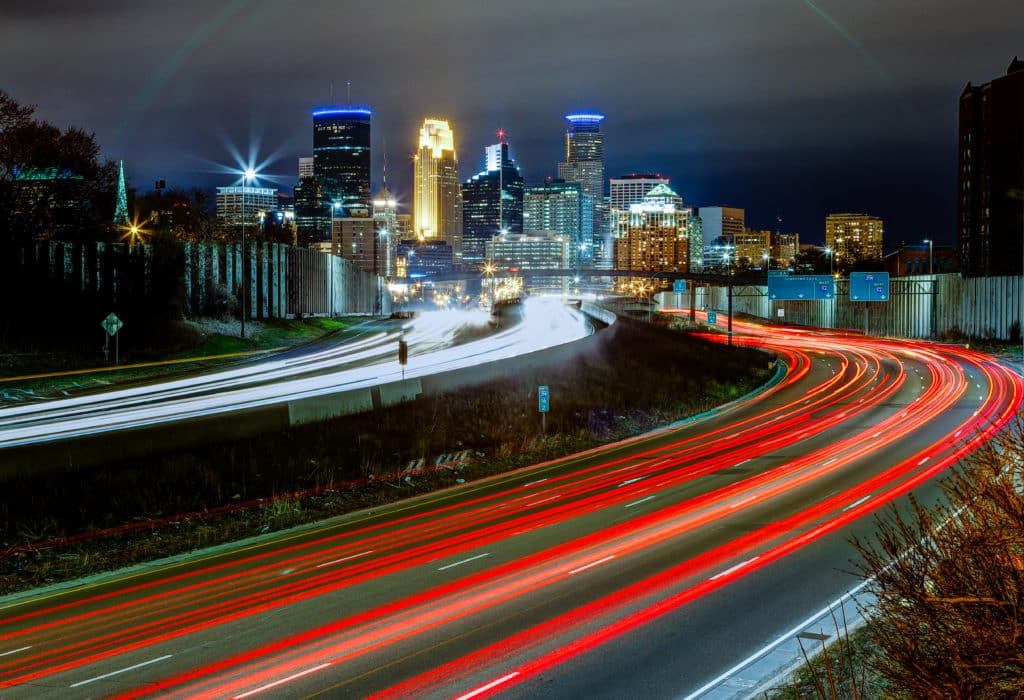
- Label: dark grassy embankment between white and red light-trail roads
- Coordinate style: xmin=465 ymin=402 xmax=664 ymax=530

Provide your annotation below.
xmin=0 ymin=321 xmax=769 ymax=593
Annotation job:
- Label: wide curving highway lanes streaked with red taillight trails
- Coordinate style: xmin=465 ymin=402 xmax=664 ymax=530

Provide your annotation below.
xmin=0 ymin=315 xmax=1024 ymax=699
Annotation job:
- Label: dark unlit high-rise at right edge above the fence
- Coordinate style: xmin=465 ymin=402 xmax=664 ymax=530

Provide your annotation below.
xmin=956 ymin=57 xmax=1024 ymax=275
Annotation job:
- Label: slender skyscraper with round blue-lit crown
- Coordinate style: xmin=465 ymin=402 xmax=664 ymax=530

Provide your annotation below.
xmin=558 ymin=114 xmax=612 ymax=267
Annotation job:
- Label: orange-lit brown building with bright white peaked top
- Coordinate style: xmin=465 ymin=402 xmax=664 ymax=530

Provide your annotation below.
xmin=614 ymin=185 xmax=690 ymax=283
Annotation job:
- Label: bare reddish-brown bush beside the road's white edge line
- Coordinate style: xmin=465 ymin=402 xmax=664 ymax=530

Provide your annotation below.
xmin=854 ymin=422 xmax=1024 ymax=698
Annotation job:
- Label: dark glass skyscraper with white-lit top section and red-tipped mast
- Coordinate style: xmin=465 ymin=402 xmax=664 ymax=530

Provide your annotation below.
xmin=462 ymin=141 xmax=523 ymax=265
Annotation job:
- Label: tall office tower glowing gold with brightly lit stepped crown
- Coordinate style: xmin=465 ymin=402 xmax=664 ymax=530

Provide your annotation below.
xmin=413 ymin=119 xmax=462 ymax=264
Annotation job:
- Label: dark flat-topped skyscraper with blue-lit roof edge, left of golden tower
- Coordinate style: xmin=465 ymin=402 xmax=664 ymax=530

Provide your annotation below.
xmin=315 ymin=107 xmax=373 ymax=212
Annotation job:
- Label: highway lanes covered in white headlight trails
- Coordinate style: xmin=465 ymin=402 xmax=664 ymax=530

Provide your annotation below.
xmin=0 ymin=298 xmax=592 ymax=449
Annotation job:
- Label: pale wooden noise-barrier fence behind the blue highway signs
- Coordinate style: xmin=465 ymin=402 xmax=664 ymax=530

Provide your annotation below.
xmin=696 ymin=273 xmax=1024 ymax=341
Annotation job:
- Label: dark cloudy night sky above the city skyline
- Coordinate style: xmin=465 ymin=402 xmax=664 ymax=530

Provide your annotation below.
xmin=0 ymin=0 xmax=1024 ymax=243
